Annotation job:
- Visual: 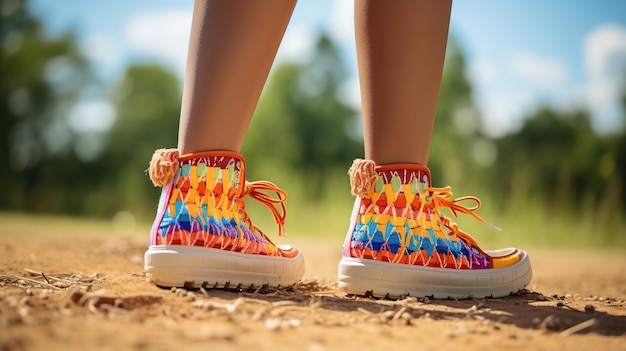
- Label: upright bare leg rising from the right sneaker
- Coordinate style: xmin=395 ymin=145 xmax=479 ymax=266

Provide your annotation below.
xmin=355 ymin=0 xmax=452 ymax=165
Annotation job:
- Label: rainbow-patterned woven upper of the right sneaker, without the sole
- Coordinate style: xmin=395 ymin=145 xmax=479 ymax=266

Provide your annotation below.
xmin=346 ymin=168 xmax=493 ymax=269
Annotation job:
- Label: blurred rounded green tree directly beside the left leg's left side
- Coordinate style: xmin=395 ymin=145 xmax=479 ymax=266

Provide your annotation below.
xmin=98 ymin=64 xmax=181 ymax=219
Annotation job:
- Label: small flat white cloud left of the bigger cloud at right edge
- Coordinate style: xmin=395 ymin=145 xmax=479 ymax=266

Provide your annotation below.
xmin=510 ymin=53 xmax=568 ymax=86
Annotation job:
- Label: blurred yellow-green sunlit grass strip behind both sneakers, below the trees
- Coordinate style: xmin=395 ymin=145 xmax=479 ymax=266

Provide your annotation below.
xmin=0 ymin=174 xmax=626 ymax=251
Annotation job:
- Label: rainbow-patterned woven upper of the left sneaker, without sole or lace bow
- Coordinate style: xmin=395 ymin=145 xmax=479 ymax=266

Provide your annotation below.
xmin=152 ymin=156 xmax=280 ymax=256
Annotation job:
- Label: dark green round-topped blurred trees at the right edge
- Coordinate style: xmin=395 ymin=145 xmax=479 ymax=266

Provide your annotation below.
xmin=491 ymin=107 xmax=624 ymax=219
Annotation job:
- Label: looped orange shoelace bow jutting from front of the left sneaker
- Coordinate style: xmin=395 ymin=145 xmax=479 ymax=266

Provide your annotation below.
xmin=241 ymin=180 xmax=287 ymax=240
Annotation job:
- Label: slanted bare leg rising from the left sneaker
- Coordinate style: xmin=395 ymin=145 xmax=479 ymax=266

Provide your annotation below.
xmin=178 ymin=0 xmax=296 ymax=154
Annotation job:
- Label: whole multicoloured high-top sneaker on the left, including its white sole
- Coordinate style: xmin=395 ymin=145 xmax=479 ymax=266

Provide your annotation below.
xmin=145 ymin=149 xmax=304 ymax=288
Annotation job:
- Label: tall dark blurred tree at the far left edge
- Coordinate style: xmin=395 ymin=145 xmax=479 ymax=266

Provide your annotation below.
xmin=0 ymin=0 xmax=91 ymax=211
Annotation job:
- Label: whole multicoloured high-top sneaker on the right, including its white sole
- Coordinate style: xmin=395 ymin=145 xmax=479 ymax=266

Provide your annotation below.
xmin=339 ymin=160 xmax=532 ymax=298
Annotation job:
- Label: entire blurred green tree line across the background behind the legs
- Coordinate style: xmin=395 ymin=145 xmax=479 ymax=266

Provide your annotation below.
xmin=0 ymin=1 xmax=626 ymax=249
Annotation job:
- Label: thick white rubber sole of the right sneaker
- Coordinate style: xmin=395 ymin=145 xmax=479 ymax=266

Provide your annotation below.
xmin=339 ymin=252 xmax=532 ymax=299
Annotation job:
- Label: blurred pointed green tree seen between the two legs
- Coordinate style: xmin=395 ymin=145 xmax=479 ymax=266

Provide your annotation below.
xmin=244 ymin=35 xmax=363 ymax=199
